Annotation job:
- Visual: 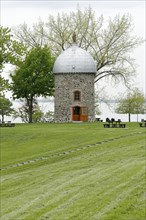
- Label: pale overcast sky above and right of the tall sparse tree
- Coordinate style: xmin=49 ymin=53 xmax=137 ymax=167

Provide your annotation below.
xmin=1 ymin=0 xmax=146 ymax=92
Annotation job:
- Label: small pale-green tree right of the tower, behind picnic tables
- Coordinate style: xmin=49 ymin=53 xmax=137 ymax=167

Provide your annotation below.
xmin=116 ymin=88 xmax=146 ymax=122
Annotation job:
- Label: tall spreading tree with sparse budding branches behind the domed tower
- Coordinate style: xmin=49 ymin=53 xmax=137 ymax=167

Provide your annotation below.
xmin=15 ymin=7 xmax=142 ymax=84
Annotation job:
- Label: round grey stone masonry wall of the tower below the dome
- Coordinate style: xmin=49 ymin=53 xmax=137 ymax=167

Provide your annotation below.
xmin=55 ymin=73 xmax=95 ymax=121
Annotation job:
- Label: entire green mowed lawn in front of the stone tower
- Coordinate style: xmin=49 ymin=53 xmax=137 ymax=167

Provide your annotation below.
xmin=0 ymin=123 xmax=146 ymax=220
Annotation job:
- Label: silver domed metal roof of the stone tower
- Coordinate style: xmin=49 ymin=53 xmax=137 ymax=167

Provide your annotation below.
xmin=53 ymin=42 xmax=96 ymax=74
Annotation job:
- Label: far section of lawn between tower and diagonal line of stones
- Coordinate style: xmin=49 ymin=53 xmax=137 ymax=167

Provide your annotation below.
xmin=1 ymin=123 xmax=143 ymax=167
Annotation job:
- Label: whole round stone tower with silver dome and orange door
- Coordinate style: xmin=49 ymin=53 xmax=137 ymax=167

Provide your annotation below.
xmin=53 ymin=33 xmax=96 ymax=122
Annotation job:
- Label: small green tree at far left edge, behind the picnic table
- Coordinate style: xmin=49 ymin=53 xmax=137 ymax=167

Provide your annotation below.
xmin=0 ymin=95 xmax=14 ymax=122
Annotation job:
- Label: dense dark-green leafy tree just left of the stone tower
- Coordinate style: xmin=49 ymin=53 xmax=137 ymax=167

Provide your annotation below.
xmin=11 ymin=46 xmax=54 ymax=123
